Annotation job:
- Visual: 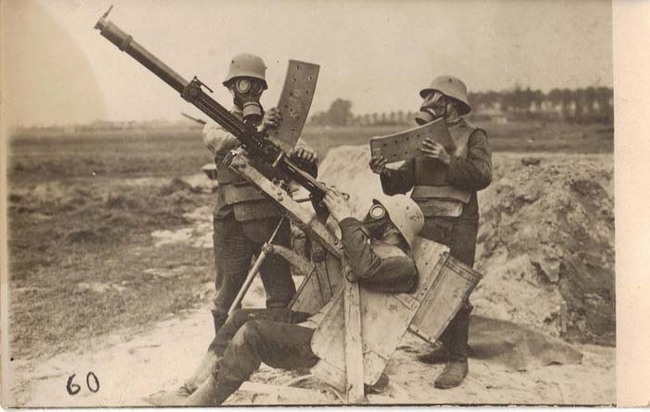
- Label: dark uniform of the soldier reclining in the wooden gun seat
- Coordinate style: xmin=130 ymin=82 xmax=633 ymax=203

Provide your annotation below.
xmin=192 ymin=218 xmax=418 ymax=405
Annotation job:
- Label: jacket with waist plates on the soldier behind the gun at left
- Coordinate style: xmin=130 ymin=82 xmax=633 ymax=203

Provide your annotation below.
xmin=203 ymin=107 xmax=309 ymax=221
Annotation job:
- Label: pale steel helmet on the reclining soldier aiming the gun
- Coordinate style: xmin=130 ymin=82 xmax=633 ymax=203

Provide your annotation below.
xmin=373 ymin=195 xmax=424 ymax=247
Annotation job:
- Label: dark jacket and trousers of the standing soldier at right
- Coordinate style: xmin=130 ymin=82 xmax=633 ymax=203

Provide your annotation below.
xmin=380 ymin=118 xmax=492 ymax=362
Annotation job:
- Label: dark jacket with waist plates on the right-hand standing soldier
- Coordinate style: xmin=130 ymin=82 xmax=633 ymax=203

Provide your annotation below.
xmin=380 ymin=119 xmax=492 ymax=222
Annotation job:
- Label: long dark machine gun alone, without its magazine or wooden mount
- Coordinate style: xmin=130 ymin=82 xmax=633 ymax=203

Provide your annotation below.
xmin=95 ymin=6 xmax=326 ymax=204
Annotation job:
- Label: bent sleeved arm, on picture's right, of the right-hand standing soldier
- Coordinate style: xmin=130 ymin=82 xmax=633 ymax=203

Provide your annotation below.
xmin=446 ymin=130 xmax=492 ymax=191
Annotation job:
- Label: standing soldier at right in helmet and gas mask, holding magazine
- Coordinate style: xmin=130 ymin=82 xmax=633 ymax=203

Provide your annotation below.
xmin=370 ymin=76 xmax=492 ymax=389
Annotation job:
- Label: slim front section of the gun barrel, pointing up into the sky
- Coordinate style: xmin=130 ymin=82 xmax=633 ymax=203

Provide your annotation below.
xmin=95 ymin=17 xmax=189 ymax=93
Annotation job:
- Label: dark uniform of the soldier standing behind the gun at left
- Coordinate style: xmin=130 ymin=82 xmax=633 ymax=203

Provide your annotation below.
xmin=203 ymin=107 xmax=314 ymax=332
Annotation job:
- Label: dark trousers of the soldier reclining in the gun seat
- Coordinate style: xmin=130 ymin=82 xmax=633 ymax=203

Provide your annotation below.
xmin=209 ymin=309 xmax=318 ymax=401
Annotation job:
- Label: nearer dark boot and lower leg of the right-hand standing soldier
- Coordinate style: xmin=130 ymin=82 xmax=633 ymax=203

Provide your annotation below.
xmin=434 ymin=302 xmax=472 ymax=389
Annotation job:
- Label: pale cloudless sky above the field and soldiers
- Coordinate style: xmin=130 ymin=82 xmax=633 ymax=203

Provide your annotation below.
xmin=1 ymin=0 xmax=613 ymax=125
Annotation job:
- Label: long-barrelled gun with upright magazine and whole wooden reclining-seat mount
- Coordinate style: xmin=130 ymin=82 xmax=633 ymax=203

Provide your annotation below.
xmin=95 ymin=6 xmax=481 ymax=404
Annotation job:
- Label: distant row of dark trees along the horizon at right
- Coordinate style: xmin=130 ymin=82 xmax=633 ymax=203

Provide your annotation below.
xmin=310 ymin=87 xmax=614 ymax=126
